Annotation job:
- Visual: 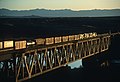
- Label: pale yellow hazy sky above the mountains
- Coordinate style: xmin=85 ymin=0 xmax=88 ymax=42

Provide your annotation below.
xmin=0 ymin=0 xmax=120 ymax=10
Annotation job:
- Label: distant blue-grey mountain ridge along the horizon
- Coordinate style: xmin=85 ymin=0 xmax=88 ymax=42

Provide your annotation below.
xmin=0 ymin=8 xmax=120 ymax=18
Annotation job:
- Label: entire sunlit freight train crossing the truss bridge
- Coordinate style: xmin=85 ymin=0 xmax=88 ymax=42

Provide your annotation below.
xmin=0 ymin=32 xmax=97 ymax=52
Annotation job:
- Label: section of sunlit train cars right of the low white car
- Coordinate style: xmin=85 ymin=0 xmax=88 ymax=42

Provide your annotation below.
xmin=34 ymin=32 xmax=97 ymax=45
